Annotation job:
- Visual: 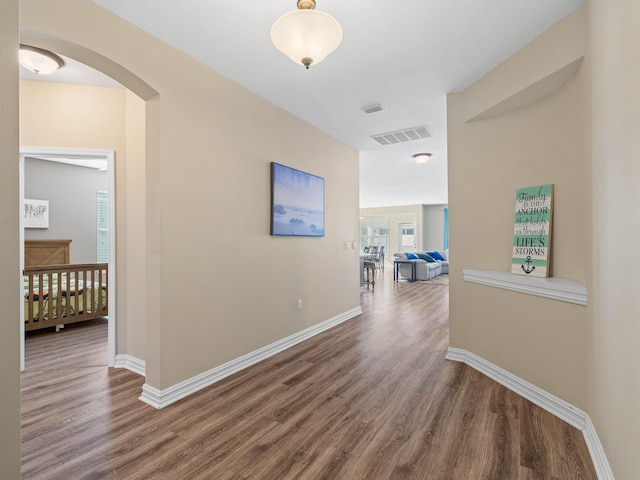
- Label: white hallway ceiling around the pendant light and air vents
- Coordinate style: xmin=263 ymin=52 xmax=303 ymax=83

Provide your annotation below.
xmin=20 ymin=0 xmax=584 ymax=208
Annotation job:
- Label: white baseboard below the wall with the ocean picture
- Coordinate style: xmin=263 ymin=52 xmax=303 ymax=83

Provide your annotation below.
xmin=140 ymin=307 xmax=362 ymax=409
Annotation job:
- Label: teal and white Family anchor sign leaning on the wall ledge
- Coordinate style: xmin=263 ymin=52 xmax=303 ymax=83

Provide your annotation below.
xmin=511 ymin=184 xmax=553 ymax=277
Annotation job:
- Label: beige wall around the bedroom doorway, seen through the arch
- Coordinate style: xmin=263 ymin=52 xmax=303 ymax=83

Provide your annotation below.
xmin=20 ymin=81 xmax=145 ymax=360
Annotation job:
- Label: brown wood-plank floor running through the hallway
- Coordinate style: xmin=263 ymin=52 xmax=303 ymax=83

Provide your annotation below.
xmin=22 ymin=271 xmax=596 ymax=480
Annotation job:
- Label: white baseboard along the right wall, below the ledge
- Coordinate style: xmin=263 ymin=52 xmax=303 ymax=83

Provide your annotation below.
xmin=446 ymin=347 xmax=614 ymax=480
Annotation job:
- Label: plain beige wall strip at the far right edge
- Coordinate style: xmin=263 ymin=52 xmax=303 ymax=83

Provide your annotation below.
xmin=588 ymin=0 xmax=640 ymax=480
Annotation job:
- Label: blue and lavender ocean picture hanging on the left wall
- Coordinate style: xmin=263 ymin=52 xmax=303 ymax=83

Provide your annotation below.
xmin=271 ymin=162 xmax=324 ymax=237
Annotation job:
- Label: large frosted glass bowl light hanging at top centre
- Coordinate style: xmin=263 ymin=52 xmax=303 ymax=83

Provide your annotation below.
xmin=271 ymin=0 xmax=342 ymax=70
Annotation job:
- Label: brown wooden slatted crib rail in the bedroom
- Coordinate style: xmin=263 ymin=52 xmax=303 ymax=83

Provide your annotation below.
xmin=23 ymin=263 xmax=109 ymax=331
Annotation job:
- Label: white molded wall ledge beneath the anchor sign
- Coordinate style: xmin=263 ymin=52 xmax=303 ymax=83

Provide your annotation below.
xmin=462 ymin=268 xmax=587 ymax=306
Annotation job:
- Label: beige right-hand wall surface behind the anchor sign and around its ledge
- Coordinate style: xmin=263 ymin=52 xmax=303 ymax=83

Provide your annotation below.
xmin=448 ymin=9 xmax=591 ymax=408
